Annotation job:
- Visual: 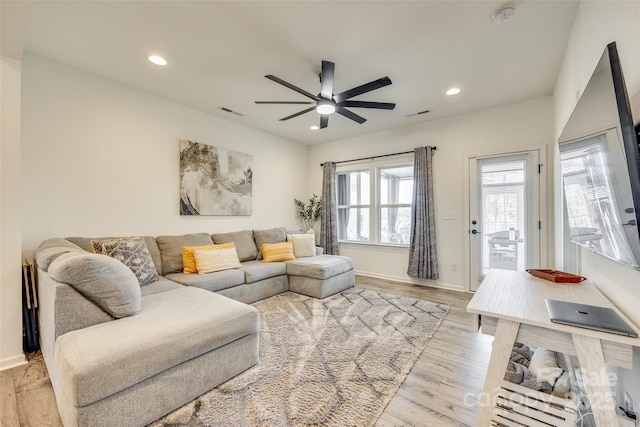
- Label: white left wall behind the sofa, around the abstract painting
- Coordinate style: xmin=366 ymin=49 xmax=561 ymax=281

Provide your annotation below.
xmin=22 ymin=55 xmax=308 ymax=256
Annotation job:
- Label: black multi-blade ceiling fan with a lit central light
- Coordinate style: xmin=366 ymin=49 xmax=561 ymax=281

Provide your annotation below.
xmin=256 ymin=61 xmax=396 ymax=129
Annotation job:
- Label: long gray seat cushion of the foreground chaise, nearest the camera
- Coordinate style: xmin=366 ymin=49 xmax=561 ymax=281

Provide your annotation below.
xmin=54 ymin=288 xmax=259 ymax=406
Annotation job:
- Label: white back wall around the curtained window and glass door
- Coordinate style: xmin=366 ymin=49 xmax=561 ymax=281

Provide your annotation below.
xmin=309 ymin=96 xmax=554 ymax=290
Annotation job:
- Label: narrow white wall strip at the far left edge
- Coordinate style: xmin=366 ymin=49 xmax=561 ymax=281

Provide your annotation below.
xmin=0 ymin=56 xmax=26 ymax=371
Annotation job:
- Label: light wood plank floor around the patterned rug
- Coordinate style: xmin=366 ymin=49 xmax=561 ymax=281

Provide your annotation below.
xmin=0 ymin=276 xmax=493 ymax=427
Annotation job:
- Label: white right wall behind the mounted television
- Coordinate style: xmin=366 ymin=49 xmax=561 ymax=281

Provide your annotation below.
xmin=553 ymin=1 xmax=640 ymax=410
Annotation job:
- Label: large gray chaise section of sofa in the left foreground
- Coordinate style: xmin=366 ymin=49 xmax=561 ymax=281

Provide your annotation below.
xmin=55 ymin=287 xmax=259 ymax=426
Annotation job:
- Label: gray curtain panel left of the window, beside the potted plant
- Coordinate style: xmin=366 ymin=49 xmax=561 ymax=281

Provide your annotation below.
xmin=320 ymin=162 xmax=339 ymax=255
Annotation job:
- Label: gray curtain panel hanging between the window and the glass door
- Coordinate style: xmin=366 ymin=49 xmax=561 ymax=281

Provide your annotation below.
xmin=407 ymin=147 xmax=439 ymax=280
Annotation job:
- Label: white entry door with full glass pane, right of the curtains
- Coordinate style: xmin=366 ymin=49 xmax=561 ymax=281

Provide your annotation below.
xmin=467 ymin=150 xmax=542 ymax=291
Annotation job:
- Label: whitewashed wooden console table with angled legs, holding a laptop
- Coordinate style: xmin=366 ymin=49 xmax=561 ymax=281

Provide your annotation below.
xmin=467 ymin=270 xmax=640 ymax=427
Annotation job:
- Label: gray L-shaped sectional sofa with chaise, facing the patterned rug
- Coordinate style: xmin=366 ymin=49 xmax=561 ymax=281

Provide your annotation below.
xmin=35 ymin=228 xmax=355 ymax=427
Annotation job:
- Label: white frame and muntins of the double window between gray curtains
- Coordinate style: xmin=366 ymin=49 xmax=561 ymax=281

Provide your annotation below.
xmin=336 ymin=154 xmax=415 ymax=248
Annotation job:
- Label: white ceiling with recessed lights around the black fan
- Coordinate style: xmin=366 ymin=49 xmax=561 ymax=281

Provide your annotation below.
xmin=18 ymin=1 xmax=578 ymax=145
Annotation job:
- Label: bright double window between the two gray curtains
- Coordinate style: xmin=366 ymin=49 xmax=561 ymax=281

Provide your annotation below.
xmin=337 ymin=161 xmax=413 ymax=245
